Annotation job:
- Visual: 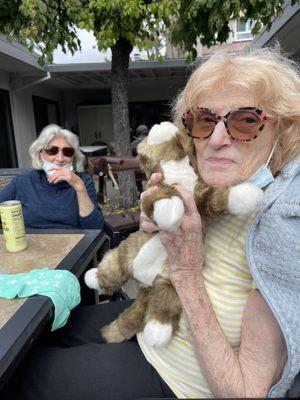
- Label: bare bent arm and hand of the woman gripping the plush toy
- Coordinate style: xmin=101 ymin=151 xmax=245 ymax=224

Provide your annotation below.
xmin=142 ymin=180 xmax=286 ymax=397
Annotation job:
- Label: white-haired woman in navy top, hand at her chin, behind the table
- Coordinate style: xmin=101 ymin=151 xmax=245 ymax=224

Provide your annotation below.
xmin=0 ymin=125 xmax=103 ymax=229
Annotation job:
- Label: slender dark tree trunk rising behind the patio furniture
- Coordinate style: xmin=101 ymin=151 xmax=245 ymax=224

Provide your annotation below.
xmin=111 ymin=38 xmax=138 ymax=208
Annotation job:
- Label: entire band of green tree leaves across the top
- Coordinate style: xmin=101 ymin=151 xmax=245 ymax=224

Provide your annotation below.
xmin=0 ymin=0 xmax=299 ymax=61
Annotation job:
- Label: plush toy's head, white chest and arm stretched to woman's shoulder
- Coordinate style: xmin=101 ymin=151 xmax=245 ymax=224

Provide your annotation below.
xmin=137 ymin=122 xmax=263 ymax=223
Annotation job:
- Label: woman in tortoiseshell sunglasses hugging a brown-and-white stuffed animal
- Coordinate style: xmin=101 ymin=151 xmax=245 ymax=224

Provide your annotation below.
xmin=2 ymin=49 xmax=300 ymax=400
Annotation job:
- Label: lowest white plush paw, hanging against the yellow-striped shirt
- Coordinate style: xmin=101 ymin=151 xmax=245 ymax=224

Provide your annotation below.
xmin=143 ymin=320 xmax=173 ymax=347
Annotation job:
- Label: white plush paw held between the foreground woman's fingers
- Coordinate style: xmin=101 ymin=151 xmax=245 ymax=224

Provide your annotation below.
xmin=153 ymin=196 xmax=184 ymax=231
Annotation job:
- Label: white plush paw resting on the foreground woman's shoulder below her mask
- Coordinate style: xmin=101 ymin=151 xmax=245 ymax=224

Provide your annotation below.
xmin=228 ymin=182 xmax=264 ymax=215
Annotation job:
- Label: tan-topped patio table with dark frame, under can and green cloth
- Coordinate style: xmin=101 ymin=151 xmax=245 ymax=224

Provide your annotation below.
xmin=0 ymin=230 xmax=109 ymax=391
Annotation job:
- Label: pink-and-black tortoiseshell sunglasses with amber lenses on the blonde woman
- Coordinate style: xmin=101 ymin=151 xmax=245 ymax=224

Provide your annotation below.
xmin=182 ymin=107 xmax=267 ymax=142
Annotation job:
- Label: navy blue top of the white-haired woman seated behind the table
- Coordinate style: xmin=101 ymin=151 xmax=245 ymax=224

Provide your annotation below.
xmin=0 ymin=170 xmax=103 ymax=229
